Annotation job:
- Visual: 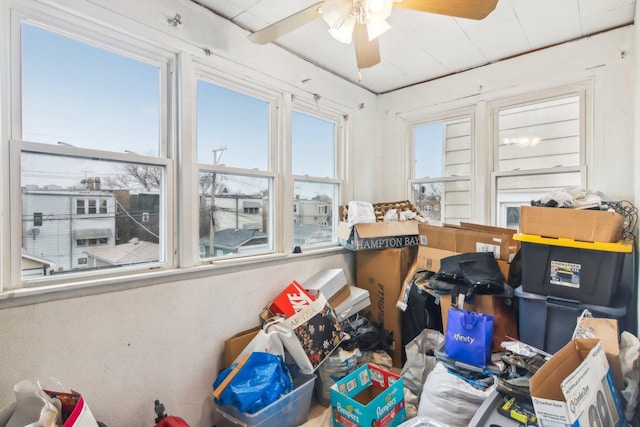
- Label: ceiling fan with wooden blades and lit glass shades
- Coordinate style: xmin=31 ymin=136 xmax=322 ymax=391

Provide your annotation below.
xmin=249 ymin=0 xmax=498 ymax=69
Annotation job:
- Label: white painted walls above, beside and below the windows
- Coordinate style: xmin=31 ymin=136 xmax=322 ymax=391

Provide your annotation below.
xmin=0 ymin=0 xmax=638 ymax=427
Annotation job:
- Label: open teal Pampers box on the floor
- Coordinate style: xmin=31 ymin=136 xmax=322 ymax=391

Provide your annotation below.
xmin=330 ymin=364 xmax=407 ymax=427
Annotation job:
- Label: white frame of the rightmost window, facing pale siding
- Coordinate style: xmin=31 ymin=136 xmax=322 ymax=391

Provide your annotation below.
xmin=487 ymin=81 xmax=593 ymax=225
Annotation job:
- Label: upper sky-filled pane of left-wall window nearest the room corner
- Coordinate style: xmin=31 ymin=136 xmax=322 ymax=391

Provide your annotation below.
xmin=291 ymin=111 xmax=336 ymax=178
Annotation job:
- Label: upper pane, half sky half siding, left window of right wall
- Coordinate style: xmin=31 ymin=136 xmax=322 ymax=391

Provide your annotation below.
xmin=414 ymin=117 xmax=472 ymax=178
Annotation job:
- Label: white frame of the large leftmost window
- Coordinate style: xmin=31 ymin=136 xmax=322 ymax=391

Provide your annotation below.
xmin=5 ymin=1 xmax=176 ymax=291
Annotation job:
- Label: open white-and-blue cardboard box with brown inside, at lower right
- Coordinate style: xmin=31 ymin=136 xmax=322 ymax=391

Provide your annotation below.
xmin=530 ymin=338 xmax=626 ymax=427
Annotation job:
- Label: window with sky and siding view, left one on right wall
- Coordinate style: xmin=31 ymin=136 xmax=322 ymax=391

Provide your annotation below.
xmin=410 ymin=114 xmax=473 ymax=224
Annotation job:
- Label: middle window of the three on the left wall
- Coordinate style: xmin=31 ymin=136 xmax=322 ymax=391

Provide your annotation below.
xmin=196 ymin=75 xmax=275 ymax=259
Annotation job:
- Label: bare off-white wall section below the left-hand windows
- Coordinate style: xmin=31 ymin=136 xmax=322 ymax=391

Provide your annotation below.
xmin=0 ymin=254 xmax=355 ymax=427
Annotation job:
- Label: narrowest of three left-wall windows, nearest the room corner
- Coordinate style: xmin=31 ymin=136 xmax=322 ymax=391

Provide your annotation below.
xmin=291 ymin=108 xmax=344 ymax=247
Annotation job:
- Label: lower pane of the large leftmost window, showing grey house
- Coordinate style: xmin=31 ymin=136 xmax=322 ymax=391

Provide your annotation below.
xmin=21 ymin=153 xmax=164 ymax=277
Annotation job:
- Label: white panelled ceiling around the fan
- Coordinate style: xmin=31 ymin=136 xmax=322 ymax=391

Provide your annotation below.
xmin=192 ymin=0 xmax=636 ymax=94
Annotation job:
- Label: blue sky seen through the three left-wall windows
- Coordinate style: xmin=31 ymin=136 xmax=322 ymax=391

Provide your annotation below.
xmin=22 ymin=24 xmax=335 ymax=195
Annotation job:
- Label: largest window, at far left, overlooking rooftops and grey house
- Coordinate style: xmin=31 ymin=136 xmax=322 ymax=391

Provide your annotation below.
xmin=10 ymin=11 xmax=172 ymax=287
